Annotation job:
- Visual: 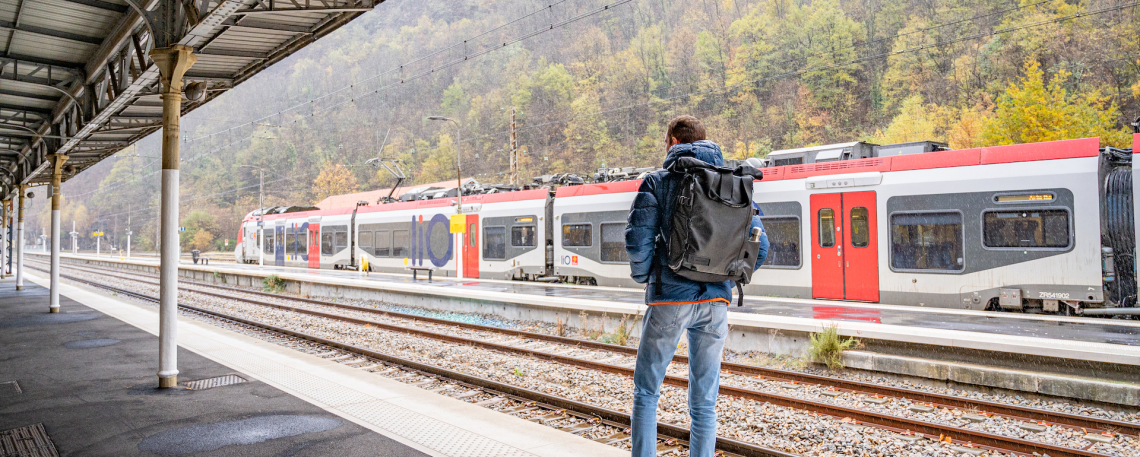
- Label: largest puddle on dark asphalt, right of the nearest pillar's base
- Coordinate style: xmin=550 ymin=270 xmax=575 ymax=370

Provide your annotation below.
xmin=139 ymin=415 xmax=341 ymax=456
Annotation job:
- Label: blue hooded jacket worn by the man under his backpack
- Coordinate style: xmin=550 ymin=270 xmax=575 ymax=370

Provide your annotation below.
xmin=626 ymin=140 xmax=768 ymax=304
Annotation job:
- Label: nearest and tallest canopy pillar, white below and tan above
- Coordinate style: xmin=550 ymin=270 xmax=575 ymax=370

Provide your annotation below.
xmin=150 ymin=44 xmax=197 ymax=389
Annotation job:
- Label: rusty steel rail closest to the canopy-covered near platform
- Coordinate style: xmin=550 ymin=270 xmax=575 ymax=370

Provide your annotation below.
xmin=38 ymin=263 xmax=796 ymax=457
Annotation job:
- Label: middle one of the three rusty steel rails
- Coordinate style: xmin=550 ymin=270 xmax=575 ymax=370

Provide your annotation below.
xmin=42 ymin=262 xmax=1104 ymax=457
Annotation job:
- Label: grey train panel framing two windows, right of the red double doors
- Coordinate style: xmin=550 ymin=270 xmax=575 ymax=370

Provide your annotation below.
xmin=879 ymin=188 xmax=1075 ymax=275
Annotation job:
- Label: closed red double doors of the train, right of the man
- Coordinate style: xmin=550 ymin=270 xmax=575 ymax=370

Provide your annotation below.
xmin=811 ymin=191 xmax=879 ymax=302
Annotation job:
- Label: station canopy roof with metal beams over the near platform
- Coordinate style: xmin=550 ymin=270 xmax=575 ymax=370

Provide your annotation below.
xmin=0 ymin=0 xmax=382 ymax=198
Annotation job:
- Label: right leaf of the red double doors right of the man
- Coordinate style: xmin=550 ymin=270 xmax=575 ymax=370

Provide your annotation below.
xmin=842 ymin=191 xmax=879 ymax=302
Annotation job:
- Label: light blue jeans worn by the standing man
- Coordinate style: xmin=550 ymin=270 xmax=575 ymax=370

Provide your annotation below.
xmin=632 ymin=303 xmax=728 ymax=457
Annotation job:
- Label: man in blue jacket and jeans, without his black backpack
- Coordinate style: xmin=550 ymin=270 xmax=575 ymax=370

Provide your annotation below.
xmin=626 ymin=116 xmax=768 ymax=457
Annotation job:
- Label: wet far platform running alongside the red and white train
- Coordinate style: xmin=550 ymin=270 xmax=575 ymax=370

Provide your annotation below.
xmin=30 ymin=254 xmax=1140 ymax=405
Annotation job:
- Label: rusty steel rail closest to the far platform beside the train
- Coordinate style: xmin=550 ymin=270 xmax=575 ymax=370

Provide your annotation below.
xmin=49 ymin=258 xmax=1140 ymax=436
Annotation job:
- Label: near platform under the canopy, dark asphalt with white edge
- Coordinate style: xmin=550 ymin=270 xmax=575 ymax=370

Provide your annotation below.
xmin=0 ymin=270 xmax=622 ymax=457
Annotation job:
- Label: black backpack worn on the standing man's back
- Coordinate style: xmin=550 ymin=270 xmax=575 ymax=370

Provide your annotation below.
xmin=658 ymin=157 xmax=764 ymax=305
